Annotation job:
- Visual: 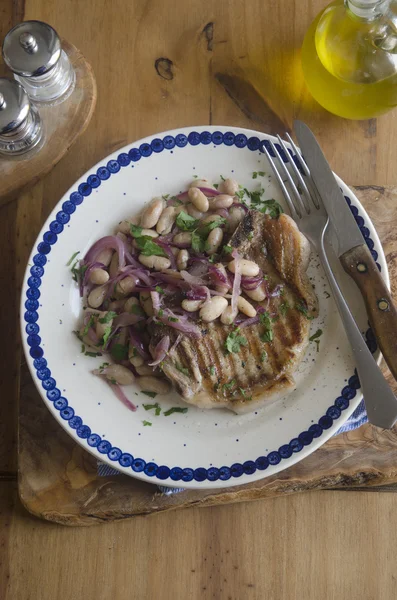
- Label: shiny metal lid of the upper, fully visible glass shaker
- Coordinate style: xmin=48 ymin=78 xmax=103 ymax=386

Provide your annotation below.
xmin=3 ymin=21 xmax=62 ymax=77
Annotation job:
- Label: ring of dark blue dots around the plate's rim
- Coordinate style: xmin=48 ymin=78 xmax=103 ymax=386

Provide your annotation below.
xmin=23 ymin=131 xmax=381 ymax=483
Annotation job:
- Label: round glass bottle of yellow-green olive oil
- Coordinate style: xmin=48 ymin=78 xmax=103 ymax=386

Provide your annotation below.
xmin=302 ymin=0 xmax=397 ymax=119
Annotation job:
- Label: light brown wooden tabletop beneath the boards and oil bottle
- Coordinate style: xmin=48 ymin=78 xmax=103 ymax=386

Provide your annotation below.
xmin=0 ymin=0 xmax=397 ymax=600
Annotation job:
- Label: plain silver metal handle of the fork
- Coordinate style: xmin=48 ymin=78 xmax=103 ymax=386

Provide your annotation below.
xmin=316 ymin=232 xmax=397 ymax=429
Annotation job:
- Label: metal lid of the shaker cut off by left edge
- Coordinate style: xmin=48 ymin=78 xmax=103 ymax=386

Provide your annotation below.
xmin=0 ymin=77 xmax=30 ymax=135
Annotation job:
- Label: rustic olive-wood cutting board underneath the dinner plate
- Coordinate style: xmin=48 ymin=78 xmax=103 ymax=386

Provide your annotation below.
xmin=18 ymin=186 xmax=397 ymax=526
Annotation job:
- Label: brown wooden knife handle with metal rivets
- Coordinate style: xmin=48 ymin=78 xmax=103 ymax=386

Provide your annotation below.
xmin=340 ymin=244 xmax=397 ymax=379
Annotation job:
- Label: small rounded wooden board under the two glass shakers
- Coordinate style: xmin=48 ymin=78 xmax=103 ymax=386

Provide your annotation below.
xmin=0 ymin=41 xmax=97 ymax=205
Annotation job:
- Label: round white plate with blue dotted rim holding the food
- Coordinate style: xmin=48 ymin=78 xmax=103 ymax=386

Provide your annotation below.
xmin=21 ymin=127 xmax=389 ymax=488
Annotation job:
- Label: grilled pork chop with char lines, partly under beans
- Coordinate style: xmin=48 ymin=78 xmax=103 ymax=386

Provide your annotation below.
xmin=151 ymin=211 xmax=317 ymax=413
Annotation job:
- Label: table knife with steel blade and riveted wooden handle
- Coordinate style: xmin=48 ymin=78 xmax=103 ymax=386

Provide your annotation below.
xmin=294 ymin=121 xmax=397 ymax=379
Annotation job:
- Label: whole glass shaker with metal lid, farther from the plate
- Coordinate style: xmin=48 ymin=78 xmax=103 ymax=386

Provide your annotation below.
xmin=3 ymin=21 xmax=76 ymax=105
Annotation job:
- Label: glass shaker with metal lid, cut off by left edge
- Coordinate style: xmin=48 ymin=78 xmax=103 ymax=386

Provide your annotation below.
xmin=0 ymin=77 xmax=44 ymax=157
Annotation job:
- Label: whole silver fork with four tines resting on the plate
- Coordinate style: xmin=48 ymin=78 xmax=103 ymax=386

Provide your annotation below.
xmin=263 ymin=133 xmax=397 ymax=429
